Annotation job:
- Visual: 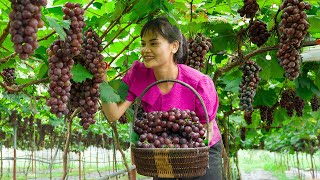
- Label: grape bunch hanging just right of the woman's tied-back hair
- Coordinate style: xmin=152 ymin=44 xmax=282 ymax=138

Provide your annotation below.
xmin=186 ymin=33 xmax=213 ymax=70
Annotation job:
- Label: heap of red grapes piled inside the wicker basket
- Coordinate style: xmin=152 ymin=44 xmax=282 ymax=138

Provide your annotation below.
xmin=134 ymin=108 xmax=205 ymax=148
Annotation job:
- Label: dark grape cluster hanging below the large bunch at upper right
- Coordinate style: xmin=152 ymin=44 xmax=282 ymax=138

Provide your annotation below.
xmin=280 ymin=89 xmax=305 ymax=117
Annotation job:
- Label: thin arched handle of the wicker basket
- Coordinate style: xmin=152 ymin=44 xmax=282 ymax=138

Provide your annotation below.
xmin=134 ymin=79 xmax=210 ymax=144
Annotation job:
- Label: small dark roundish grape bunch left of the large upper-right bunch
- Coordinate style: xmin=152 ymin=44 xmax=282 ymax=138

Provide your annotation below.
xmin=249 ymin=20 xmax=270 ymax=47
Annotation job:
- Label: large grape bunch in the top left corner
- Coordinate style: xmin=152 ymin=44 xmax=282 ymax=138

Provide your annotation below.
xmin=9 ymin=0 xmax=47 ymax=60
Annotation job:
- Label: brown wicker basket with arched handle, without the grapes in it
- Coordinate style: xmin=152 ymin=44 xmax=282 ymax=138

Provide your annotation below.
xmin=131 ymin=80 xmax=209 ymax=178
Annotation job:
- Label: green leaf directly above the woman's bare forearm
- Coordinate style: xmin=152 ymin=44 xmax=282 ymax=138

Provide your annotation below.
xmin=99 ymin=82 xmax=121 ymax=104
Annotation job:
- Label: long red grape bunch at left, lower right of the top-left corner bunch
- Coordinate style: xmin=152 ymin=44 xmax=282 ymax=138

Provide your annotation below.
xmin=47 ymin=40 xmax=74 ymax=117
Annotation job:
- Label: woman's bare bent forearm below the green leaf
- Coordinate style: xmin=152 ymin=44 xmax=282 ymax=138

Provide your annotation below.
xmin=102 ymin=100 xmax=132 ymax=122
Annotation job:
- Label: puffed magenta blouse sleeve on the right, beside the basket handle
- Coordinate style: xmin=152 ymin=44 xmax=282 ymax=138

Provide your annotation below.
xmin=195 ymin=76 xmax=219 ymax=124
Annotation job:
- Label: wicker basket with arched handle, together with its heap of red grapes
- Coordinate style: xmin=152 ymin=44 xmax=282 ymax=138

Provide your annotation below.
xmin=131 ymin=80 xmax=209 ymax=178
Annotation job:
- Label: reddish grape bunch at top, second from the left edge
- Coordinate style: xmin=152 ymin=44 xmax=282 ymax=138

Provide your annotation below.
xmin=62 ymin=2 xmax=85 ymax=56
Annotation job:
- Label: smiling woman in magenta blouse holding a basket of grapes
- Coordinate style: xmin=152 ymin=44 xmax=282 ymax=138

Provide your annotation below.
xmin=103 ymin=17 xmax=222 ymax=180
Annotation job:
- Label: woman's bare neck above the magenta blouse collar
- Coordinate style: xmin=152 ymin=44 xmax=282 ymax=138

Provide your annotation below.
xmin=153 ymin=63 xmax=179 ymax=80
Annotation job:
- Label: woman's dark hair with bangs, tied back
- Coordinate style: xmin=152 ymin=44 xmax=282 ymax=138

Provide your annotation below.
xmin=140 ymin=17 xmax=188 ymax=64
